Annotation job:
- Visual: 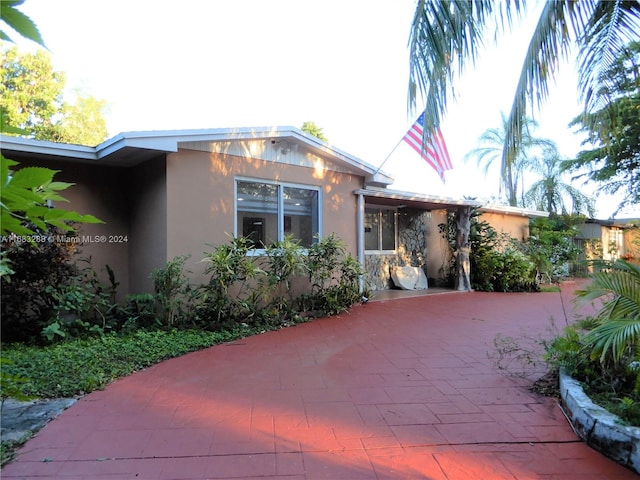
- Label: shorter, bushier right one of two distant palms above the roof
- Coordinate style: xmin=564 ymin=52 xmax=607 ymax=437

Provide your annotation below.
xmin=523 ymin=145 xmax=594 ymax=217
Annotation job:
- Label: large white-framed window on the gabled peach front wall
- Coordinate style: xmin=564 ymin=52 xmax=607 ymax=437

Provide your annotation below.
xmin=236 ymin=180 xmax=320 ymax=248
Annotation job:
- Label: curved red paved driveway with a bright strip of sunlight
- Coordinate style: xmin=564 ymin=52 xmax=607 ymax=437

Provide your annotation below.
xmin=1 ymin=285 xmax=637 ymax=480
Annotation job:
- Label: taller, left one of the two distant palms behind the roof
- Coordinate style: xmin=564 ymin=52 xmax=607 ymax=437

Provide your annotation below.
xmin=464 ymin=114 xmax=553 ymax=207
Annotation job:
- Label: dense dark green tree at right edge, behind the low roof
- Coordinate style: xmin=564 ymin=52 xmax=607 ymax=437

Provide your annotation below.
xmin=564 ymin=42 xmax=640 ymax=215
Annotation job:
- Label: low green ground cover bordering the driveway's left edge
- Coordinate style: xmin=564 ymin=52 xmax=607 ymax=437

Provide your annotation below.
xmin=2 ymin=327 xmax=261 ymax=398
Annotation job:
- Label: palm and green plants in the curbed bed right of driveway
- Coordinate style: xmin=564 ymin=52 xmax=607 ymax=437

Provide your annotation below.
xmin=546 ymin=260 xmax=640 ymax=425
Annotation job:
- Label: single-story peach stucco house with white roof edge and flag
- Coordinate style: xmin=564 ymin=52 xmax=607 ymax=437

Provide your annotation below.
xmin=1 ymin=127 xmax=548 ymax=293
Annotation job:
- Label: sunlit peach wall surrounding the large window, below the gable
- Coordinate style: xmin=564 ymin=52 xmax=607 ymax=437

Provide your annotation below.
xmin=167 ymin=150 xmax=362 ymax=282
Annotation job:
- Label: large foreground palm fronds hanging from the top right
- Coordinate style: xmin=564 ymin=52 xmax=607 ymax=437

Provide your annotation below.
xmin=409 ymin=0 xmax=640 ymax=193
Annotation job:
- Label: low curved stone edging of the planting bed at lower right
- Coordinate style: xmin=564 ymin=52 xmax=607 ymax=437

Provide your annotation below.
xmin=560 ymin=370 xmax=640 ymax=473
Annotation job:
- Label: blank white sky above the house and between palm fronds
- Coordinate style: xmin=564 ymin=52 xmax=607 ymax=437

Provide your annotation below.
xmin=12 ymin=0 xmax=640 ymax=218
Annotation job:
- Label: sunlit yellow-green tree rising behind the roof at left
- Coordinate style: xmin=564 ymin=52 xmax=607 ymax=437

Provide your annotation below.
xmin=0 ymin=47 xmax=107 ymax=145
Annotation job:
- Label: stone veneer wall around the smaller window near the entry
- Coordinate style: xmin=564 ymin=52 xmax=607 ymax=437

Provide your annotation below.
xmin=364 ymin=208 xmax=431 ymax=290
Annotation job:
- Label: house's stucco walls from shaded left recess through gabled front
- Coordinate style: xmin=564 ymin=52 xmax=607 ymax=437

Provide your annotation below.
xmin=3 ymin=132 xmax=365 ymax=299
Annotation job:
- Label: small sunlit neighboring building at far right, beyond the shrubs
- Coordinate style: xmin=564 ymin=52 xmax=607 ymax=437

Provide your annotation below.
xmin=576 ymin=219 xmax=640 ymax=272
